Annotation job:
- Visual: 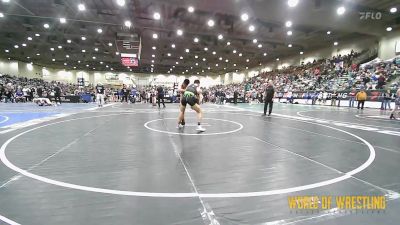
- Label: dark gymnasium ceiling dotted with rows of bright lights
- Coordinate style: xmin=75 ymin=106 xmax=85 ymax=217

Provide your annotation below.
xmin=0 ymin=0 xmax=400 ymax=75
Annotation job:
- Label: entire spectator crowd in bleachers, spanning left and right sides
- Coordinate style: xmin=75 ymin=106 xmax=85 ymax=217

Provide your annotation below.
xmin=0 ymin=51 xmax=400 ymax=103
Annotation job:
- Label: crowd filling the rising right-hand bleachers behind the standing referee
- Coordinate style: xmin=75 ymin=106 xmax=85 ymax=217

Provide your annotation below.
xmin=208 ymin=51 xmax=400 ymax=102
